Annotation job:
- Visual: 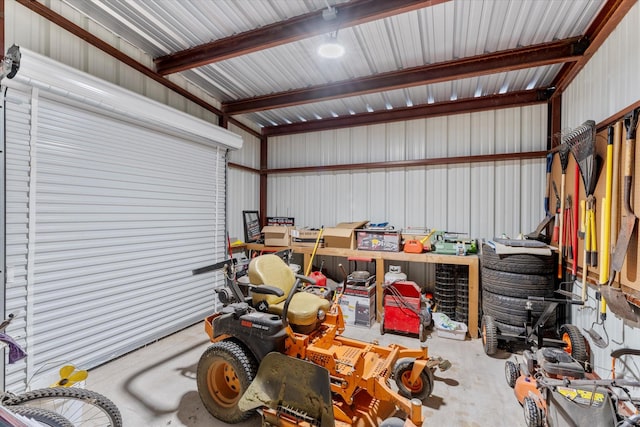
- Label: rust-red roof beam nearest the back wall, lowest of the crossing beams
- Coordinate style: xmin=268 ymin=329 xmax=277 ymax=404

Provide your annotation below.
xmin=262 ymin=89 xmax=553 ymax=136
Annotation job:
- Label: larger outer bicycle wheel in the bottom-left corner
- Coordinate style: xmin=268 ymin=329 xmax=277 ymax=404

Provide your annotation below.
xmin=4 ymin=387 xmax=122 ymax=427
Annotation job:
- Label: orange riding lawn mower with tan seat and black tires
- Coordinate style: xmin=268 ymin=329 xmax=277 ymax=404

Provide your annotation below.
xmin=193 ymin=254 xmax=450 ymax=427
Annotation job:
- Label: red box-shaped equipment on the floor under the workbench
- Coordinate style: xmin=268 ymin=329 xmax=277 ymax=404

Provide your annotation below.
xmin=380 ymin=281 xmax=423 ymax=335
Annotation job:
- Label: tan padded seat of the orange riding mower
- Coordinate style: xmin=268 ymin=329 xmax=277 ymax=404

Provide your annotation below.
xmin=249 ymin=254 xmax=331 ymax=329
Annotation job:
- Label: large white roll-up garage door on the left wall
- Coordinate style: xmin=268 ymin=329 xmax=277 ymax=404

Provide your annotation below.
xmin=3 ymin=49 xmax=242 ymax=391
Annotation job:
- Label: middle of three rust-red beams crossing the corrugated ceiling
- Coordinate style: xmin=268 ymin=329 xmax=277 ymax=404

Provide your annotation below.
xmin=222 ymin=37 xmax=588 ymax=115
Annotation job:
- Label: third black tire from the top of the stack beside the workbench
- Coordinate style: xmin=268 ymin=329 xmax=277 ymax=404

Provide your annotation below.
xmin=482 ymin=291 xmax=556 ymax=326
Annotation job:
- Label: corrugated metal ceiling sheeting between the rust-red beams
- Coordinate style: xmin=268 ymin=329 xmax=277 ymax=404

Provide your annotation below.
xmin=58 ymin=0 xmax=605 ymax=130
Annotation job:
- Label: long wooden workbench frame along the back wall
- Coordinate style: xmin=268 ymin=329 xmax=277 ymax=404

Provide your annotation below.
xmin=247 ymin=243 xmax=480 ymax=338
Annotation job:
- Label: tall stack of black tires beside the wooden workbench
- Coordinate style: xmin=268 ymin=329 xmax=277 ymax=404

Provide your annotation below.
xmin=481 ymin=244 xmax=556 ymax=355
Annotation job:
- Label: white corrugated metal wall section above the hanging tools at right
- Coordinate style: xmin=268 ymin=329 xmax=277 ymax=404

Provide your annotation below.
xmin=562 ymin=3 xmax=640 ymax=129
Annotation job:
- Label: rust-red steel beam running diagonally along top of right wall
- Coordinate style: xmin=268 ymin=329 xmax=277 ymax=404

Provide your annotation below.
xmin=554 ymin=0 xmax=637 ymax=95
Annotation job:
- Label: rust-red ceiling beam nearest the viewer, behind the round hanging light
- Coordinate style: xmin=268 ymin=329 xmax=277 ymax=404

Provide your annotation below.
xmin=155 ymin=0 xmax=449 ymax=75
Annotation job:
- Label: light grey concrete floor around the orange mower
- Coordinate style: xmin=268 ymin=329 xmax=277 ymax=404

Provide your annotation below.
xmin=87 ymin=324 xmax=526 ymax=427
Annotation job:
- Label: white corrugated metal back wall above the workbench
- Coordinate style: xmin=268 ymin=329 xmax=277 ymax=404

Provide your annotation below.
xmin=268 ymin=105 xmax=547 ymax=242
